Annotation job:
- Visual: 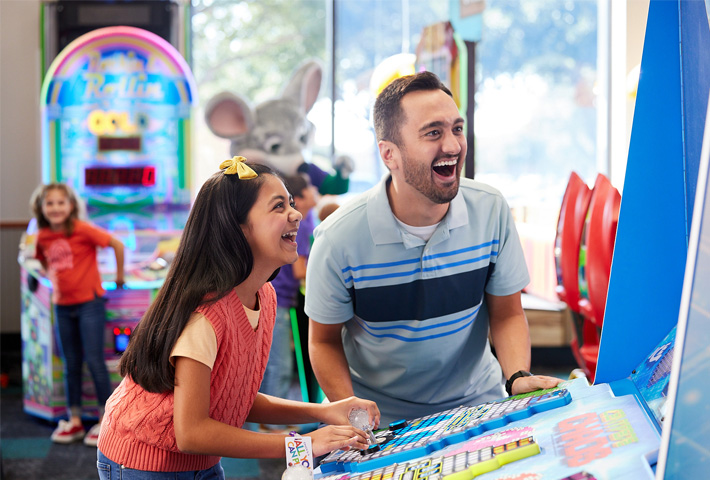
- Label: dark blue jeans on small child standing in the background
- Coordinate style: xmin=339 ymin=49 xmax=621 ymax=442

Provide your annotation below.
xmin=54 ymin=298 xmax=112 ymax=408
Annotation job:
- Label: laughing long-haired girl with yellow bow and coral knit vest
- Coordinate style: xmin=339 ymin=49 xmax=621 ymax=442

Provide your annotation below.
xmin=97 ymin=157 xmax=379 ymax=479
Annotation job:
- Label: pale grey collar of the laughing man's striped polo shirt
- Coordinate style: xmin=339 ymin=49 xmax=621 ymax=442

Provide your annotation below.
xmin=367 ymin=175 xmax=468 ymax=247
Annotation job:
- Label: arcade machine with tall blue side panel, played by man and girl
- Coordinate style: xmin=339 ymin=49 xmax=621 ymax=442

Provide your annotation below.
xmin=308 ymin=0 xmax=710 ymax=480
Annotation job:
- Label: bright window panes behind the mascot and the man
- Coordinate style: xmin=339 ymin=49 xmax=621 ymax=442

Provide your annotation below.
xmin=192 ymin=0 xmax=608 ymax=299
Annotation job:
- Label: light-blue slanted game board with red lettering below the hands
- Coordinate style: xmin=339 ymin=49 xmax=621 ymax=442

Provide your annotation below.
xmin=314 ymin=378 xmax=660 ymax=480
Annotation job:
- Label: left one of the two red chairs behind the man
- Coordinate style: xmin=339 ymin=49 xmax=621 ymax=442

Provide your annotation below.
xmin=555 ymin=172 xmax=592 ymax=377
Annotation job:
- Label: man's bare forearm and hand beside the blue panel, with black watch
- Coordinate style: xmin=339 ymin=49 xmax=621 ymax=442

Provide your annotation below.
xmin=486 ymin=292 xmax=561 ymax=395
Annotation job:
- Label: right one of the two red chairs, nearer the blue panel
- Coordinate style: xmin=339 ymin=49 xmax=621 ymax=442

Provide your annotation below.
xmin=579 ymin=174 xmax=621 ymax=382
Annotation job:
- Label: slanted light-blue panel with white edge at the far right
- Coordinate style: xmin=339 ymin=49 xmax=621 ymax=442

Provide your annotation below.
xmin=660 ymin=95 xmax=710 ymax=479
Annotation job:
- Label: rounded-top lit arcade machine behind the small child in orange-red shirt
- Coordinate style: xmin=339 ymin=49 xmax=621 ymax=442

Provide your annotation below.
xmin=20 ymin=26 xmax=196 ymax=421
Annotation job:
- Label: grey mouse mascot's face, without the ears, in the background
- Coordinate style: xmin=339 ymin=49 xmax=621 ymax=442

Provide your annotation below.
xmin=230 ymin=100 xmax=314 ymax=175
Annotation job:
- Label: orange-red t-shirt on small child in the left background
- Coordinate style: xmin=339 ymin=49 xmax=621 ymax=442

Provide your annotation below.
xmin=36 ymin=220 xmax=111 ymax=305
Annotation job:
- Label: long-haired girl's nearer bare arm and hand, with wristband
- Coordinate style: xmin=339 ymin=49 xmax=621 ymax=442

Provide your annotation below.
xmin=173 ymin=357 xmax=376 ymax=458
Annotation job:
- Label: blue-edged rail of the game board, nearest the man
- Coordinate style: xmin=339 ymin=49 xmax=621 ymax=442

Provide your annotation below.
xmin=320 ymin=389 xmax=572 ymax=473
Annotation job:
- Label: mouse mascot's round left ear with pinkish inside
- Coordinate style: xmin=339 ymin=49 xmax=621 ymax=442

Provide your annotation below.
xmin=205 ymin=92 xmax=254 ymax=138
